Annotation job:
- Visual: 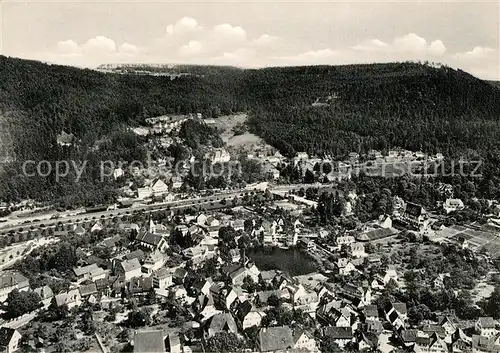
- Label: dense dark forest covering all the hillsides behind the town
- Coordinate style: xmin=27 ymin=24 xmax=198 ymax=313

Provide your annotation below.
xmin=0 ymin=56 xmax=500 ymax=206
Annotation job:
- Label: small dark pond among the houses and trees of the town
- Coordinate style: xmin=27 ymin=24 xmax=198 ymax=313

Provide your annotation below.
xmin=246 ymin=248 xmax=318 ymax=276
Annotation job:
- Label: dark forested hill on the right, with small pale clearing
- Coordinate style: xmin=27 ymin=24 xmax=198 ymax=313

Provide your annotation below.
xmin=244 ymin=63 xmax=500 ymax=156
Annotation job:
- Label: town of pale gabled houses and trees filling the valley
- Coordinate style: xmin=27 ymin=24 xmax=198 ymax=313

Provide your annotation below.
xmin=0 ymin=113 xmax=500 ymax=353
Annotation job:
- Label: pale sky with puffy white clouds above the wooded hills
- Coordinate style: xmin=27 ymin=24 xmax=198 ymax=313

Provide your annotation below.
xmin=0 ymin=0 xmax=500 ymax=80
